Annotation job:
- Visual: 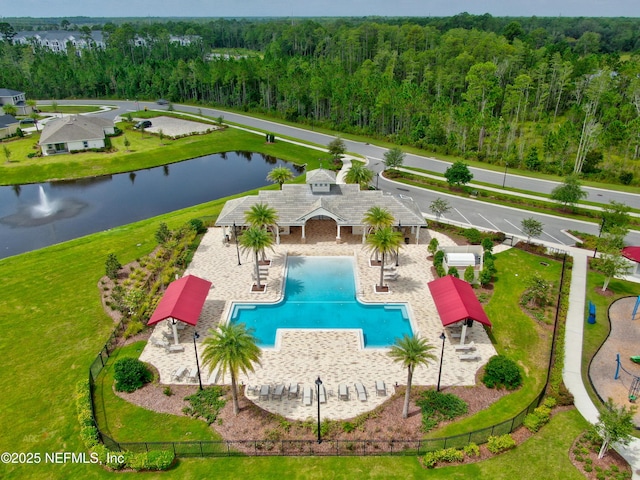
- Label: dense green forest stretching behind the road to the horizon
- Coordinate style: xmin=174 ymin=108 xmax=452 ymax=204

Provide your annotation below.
xmin=0 ymin=14 xmax=640 ymax=185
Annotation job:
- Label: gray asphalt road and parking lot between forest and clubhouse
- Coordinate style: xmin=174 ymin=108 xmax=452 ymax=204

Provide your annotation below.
xmin=51 ymin=100 xmax=640 ymax=245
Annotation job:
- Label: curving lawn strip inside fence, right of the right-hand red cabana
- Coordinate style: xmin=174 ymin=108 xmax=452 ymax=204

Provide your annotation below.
xmin=429 ymin=248 xmax=562 ymax=438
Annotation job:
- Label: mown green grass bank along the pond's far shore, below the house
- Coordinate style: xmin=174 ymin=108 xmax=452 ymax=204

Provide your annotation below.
xmin=0 ymin=124 xmax=319 ymax=185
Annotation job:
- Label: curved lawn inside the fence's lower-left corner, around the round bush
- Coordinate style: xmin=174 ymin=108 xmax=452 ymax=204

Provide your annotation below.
xmin=94 ymin=342 xmax=221 ymax=442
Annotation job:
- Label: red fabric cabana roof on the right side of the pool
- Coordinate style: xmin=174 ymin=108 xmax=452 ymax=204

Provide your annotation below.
xmin=428 ymin=275 xmax=491 ymax=327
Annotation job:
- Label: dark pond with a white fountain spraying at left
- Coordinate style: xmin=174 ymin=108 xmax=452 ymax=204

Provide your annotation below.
xmin=0 ymin=152 xmax=302 ymax=258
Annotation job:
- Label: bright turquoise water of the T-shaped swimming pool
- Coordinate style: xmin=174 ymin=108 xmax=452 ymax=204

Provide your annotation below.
xmin=230 ymin=257 xmax=412 ymax=348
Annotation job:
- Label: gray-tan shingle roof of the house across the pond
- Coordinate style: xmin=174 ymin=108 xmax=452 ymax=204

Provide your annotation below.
xmin=40 ymin=115 xmax=113 ymax=145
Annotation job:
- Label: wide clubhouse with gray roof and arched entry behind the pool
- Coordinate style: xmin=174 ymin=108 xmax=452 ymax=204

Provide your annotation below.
xmin=216 ymin=169 xmax=427 ymax=243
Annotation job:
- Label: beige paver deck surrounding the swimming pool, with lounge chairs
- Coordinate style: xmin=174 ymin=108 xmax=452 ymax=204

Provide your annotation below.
xmin=140 ymin=222 xmax=496 ymax=420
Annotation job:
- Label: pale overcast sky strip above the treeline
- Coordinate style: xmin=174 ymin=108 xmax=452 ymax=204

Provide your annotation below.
xmin=0 ymin=0 xmax=640 ymax=17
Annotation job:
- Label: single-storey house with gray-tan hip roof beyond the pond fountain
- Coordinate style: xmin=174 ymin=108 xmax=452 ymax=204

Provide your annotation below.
xmin=39 ymin=115 xmax=115 ymax=155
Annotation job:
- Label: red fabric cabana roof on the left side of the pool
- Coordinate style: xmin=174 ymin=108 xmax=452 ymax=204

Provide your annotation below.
xmin=147 ymin=275 xmax=211 ymax=325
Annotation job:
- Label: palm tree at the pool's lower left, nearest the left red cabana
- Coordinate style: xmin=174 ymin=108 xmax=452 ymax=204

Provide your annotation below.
xmin=202 ymin=323 xmax=262 ymax=415
